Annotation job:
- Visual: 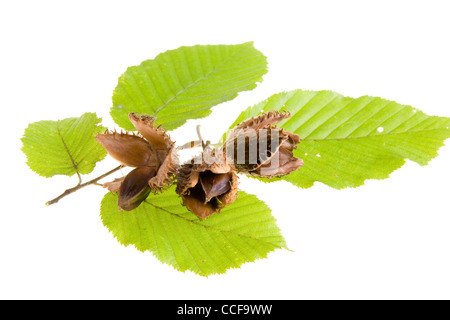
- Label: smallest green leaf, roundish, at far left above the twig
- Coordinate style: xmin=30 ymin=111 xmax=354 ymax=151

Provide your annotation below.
xmin=22 ymin=113 xmax=106 ymax=177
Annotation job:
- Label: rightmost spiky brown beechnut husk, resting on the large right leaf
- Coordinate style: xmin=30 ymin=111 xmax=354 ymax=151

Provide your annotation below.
xmin=223 ymin=111 xmax=303 ymax=178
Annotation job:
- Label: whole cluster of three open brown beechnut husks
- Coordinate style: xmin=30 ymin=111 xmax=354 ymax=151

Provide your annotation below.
xmin=96 ymin=111 xmax=303 ymax=219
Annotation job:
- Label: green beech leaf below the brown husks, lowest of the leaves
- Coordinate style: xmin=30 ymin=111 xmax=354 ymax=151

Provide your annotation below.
xmin=101 ymin=187 xmax=286 ymax=276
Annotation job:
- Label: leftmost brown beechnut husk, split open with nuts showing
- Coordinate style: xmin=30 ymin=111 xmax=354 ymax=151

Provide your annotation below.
xmin=96 ymin=113 xmax=177 ymax=211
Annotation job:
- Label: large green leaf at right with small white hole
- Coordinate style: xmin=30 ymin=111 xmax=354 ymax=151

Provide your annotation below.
xmin=230 ymin=90 xmax=450 ymax=189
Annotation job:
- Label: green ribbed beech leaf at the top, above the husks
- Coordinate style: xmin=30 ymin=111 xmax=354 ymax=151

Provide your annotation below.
xmin=111 ymin=42 xmax=267 ymax=130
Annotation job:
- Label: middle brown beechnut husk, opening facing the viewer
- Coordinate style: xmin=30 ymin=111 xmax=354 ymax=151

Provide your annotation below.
xmin=176 ymin=151 xmax=238 ymax=219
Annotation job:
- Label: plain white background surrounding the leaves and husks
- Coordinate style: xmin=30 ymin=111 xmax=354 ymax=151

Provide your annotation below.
xmin=0 ymin=0 xmax=450 ymax=299
